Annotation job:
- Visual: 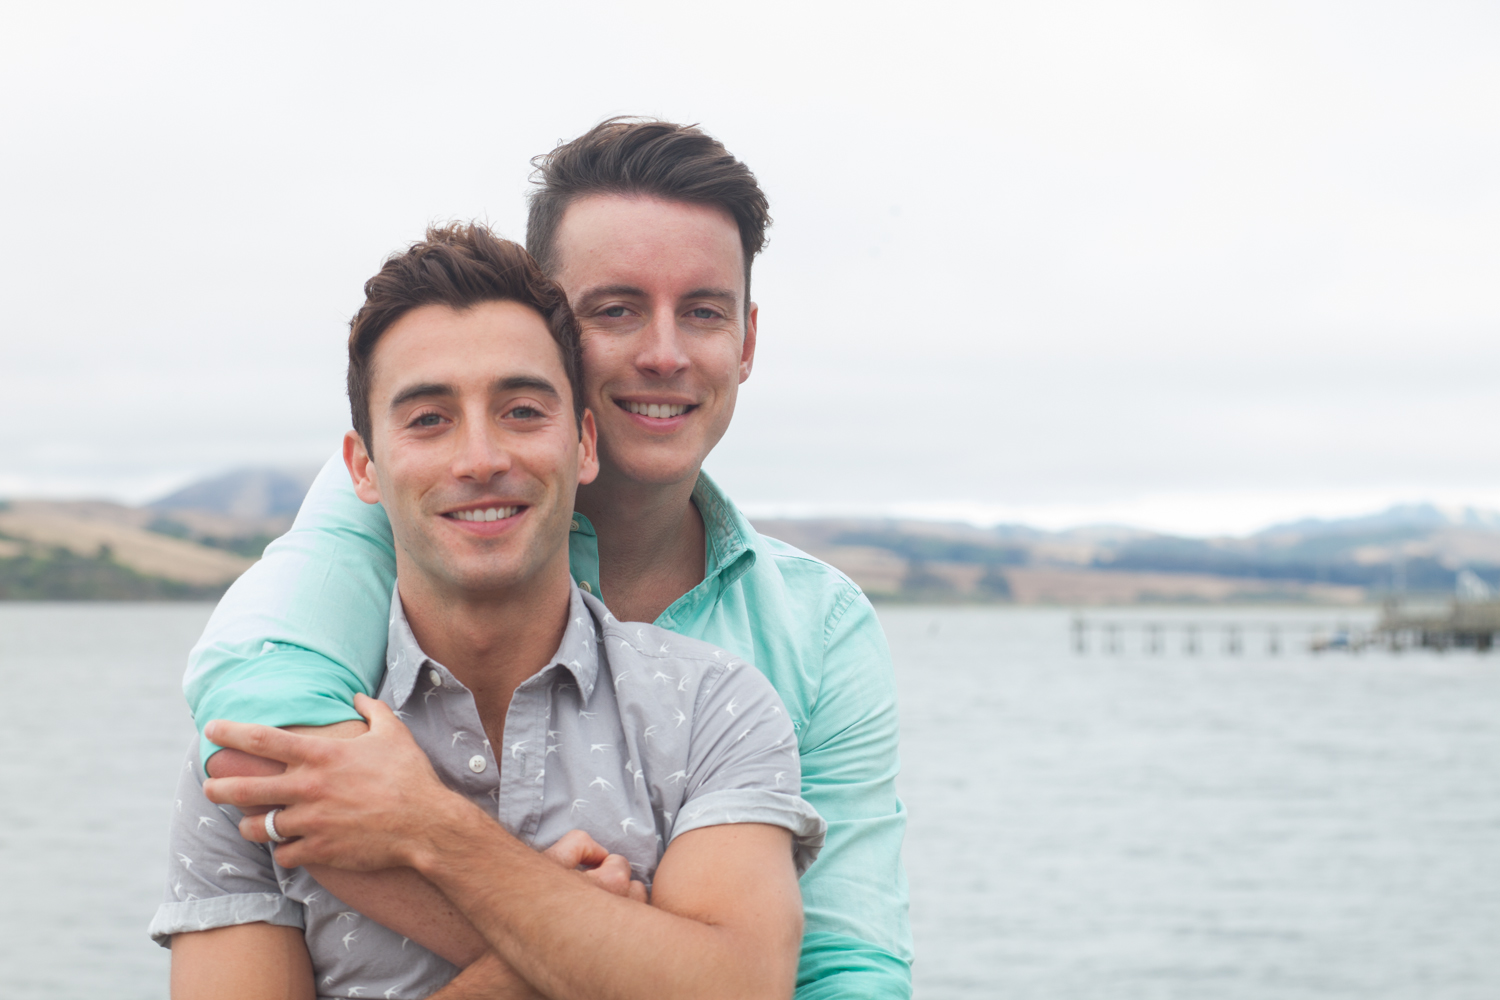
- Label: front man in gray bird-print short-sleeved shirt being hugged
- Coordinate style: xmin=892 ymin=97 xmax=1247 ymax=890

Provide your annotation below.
xmin=152 ymin=226 xmax=824 ymax=1000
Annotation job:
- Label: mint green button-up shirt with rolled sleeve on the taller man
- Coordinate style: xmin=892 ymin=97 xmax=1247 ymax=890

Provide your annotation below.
xmin=183 ymin=457 xmax=912 ymax=1000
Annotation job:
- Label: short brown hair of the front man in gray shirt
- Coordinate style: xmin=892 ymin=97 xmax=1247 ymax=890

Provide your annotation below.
xmin=348 ymin=222 xmax=584 ymax=450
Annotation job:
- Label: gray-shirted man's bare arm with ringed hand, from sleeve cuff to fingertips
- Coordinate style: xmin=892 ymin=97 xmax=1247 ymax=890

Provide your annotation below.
xmin=189 ymin=696 xmax=801 ymax=1000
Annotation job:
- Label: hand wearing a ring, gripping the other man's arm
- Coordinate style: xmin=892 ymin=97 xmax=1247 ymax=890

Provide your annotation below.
xmin=203 ymin=694 xmax=468 ymax=871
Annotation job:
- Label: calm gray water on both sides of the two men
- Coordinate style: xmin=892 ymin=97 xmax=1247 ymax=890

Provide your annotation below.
xmin=0 ymin=604 xmax=1500 ymax=1000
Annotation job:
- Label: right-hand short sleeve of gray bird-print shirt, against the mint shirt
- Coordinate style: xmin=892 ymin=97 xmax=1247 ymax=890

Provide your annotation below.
xmin=672 ymin=658 xmax=827 ymax=876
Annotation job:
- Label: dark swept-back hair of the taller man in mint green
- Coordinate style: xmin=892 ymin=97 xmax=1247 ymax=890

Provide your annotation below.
xmin=527 ymin=117 xmax=771 ymax=310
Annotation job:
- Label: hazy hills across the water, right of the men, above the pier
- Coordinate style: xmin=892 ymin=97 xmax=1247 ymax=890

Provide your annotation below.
xmin=756 ymin=504 xmax=1500 ymax=604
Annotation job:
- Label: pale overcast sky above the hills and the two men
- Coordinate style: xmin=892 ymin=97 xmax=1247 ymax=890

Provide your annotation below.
xmin=0 ymin=0 xmax=1500 ymax=532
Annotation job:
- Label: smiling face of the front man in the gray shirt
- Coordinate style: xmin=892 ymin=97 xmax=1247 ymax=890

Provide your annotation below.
xmin=344 ymin=301 xmax=599 ymax=594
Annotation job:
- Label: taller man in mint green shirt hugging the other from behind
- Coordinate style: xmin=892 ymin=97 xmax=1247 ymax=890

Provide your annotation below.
xmin=185 ymin=120 xmax=911 ymax=1000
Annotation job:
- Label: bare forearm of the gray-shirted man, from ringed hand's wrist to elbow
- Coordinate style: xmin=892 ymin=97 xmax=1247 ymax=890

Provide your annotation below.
xmin=413 ymin=796 xmax=800 ymax=1000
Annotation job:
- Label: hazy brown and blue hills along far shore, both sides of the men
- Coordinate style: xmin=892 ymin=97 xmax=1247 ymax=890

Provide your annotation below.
xmin=0 ymin=468 xmax=1500 ymax=604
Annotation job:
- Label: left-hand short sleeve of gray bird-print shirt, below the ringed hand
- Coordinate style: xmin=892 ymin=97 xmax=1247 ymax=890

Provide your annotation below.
xmin=150 ymin=739 xmax=305 ymax=948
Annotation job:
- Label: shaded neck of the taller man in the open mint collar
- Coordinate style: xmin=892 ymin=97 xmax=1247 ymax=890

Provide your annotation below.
xmin=575 ymin=468 xmax=707 ymax=622
